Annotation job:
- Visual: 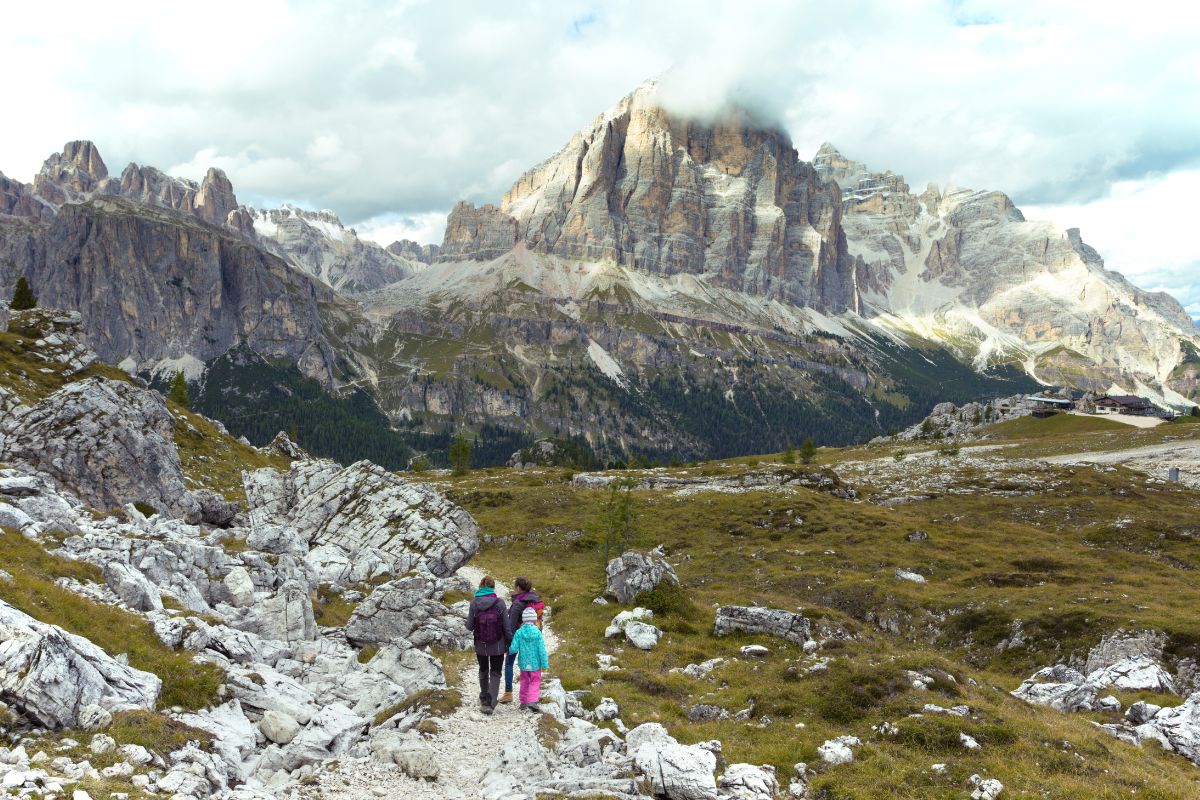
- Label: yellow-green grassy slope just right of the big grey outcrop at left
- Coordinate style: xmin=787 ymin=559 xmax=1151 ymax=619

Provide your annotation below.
xmin=168 ymin=403 xmax=292 ymax=505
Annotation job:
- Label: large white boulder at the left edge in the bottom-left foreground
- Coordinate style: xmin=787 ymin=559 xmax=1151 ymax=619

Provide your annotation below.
xmin=0 ymin=601 xmax=162 ymax=728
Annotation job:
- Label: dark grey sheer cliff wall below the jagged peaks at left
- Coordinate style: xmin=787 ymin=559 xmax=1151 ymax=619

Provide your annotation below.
xmin=0 ymin=197 xmax=366 ymax=384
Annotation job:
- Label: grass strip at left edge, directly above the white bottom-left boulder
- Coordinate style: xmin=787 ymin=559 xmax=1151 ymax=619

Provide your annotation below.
xmin=0 ymin=529 xmax=224 ymax=709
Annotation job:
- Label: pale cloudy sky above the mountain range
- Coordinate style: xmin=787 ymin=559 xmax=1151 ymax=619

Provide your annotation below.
xmin=7 ymin=0 xmax=1200 ymax=317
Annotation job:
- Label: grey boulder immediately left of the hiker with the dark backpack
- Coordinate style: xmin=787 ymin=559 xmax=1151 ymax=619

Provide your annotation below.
xmin=346 ymin=575 xmax=470 ymax=649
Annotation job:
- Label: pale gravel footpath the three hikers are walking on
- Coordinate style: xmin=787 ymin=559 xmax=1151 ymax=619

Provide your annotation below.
xmin=292 ymin=566 xmax=558 ymax=800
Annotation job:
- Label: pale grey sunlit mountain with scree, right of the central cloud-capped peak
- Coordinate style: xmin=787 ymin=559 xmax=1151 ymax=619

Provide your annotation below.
xmin=814 ymin=144 xmax=1196 ymax=402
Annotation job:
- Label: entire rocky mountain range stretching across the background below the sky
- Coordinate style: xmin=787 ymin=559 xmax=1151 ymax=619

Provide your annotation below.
xmin=0 ymin=83 xmax=1200 ymax=464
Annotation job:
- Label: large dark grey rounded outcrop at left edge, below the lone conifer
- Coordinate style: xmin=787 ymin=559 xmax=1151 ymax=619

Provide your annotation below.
xmin=0 ymin=378 xmax=199 ymax=517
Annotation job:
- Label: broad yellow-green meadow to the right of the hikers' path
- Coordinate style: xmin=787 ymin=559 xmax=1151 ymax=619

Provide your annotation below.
xmin=444 ymin=431 xmax=1200 ymax=799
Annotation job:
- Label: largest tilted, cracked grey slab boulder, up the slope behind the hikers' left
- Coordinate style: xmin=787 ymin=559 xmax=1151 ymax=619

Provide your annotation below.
xmin=244 ymin=461 xmax=479 ymax=577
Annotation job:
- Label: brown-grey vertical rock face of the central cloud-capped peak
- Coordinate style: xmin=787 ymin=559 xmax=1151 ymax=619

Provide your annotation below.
xmin=439 ymin=85 xmax=858 ymax=312
